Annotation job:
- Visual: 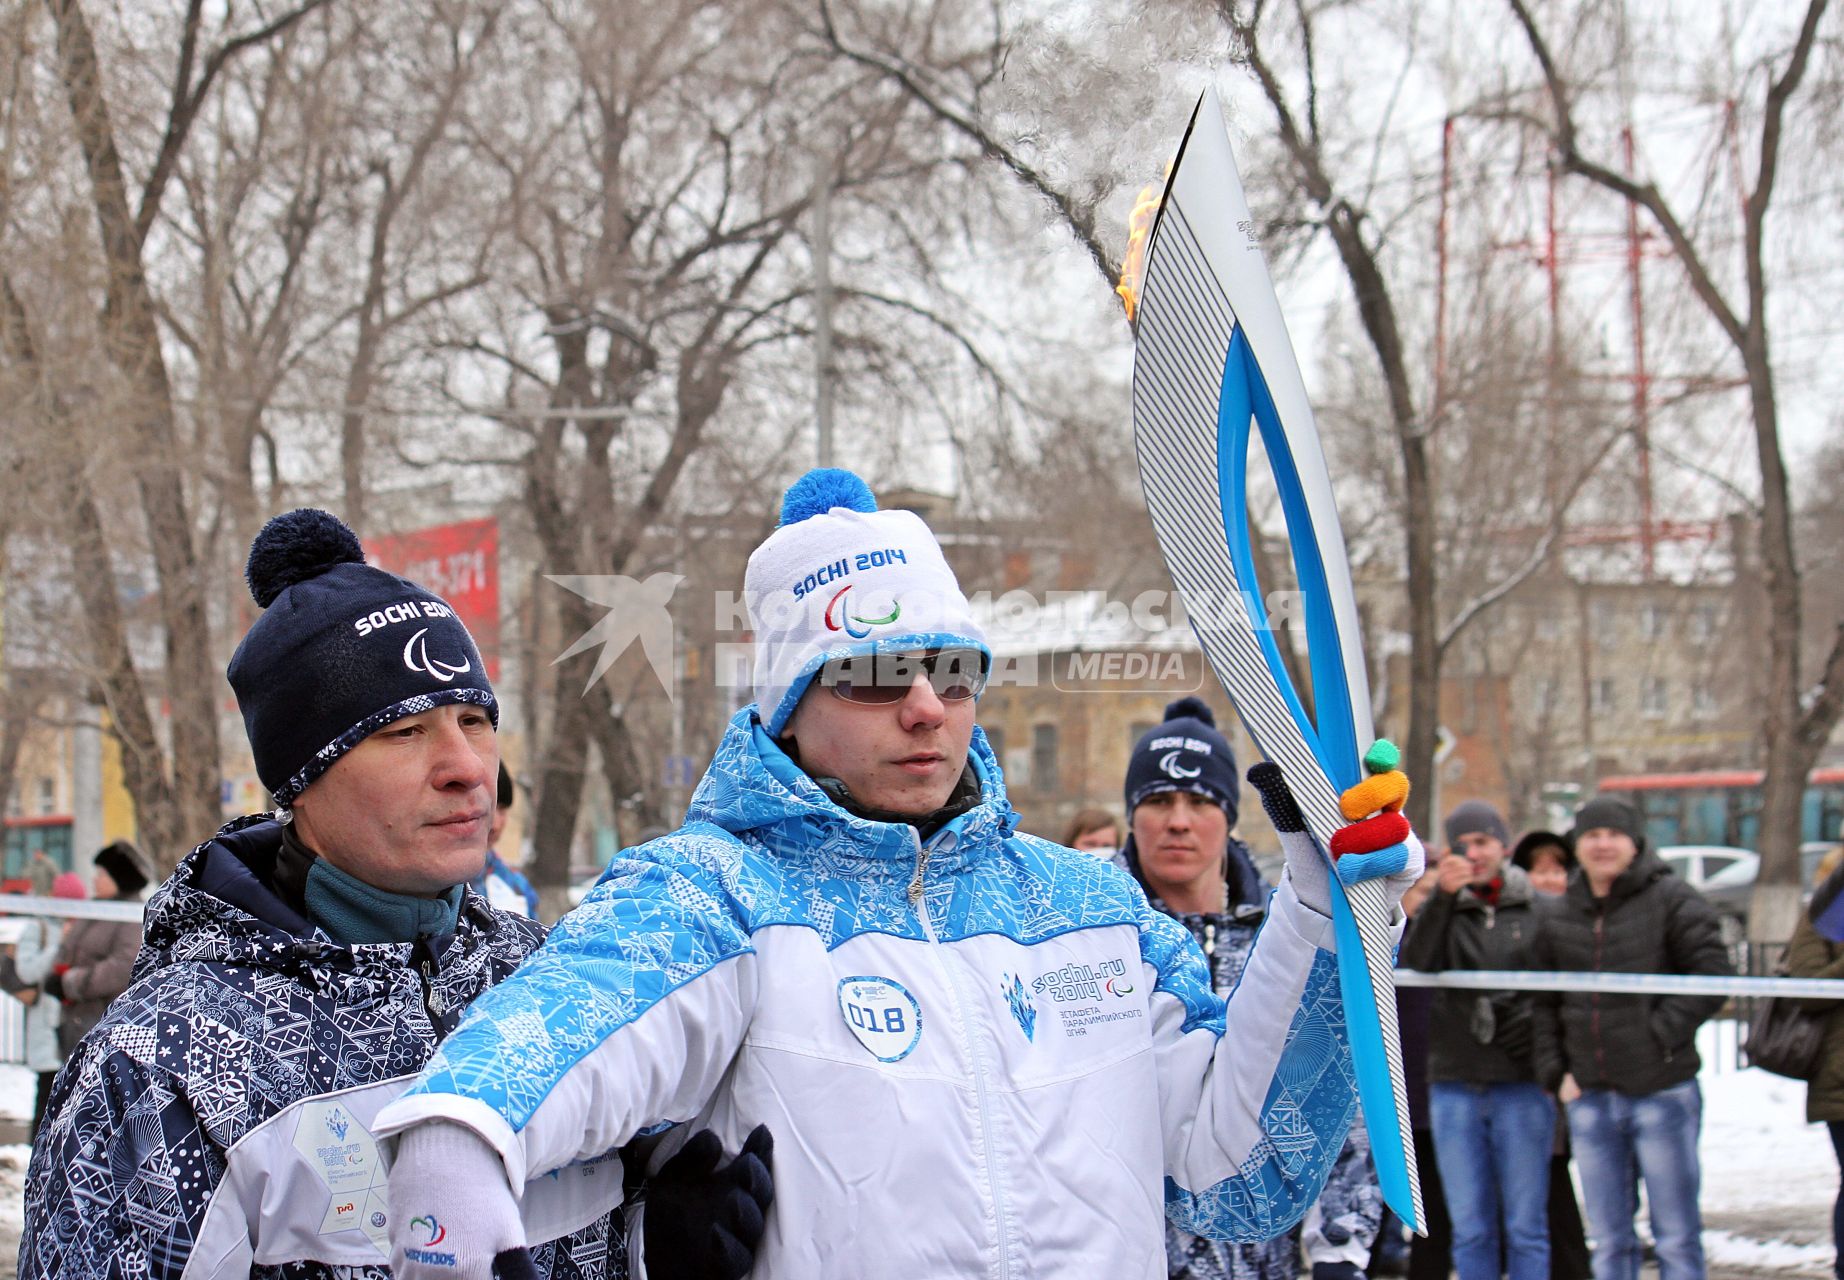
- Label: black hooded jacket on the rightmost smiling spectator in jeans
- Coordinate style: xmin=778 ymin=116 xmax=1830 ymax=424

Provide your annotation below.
xmin=1531 ymin=845 xmax=1735 ymax=1096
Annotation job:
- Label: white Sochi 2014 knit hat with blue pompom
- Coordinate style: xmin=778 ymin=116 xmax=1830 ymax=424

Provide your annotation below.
xmin=743 ymin=467 xmax=992 ymax=734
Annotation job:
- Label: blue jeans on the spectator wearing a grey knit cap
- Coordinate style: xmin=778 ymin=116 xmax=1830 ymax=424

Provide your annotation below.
xmin=1427 ymin=1081 xmax=1556 ymax=1280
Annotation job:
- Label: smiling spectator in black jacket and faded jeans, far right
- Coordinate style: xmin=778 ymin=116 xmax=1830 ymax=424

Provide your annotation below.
xmin=1532 ymin=797 xmax=1733 ymax=1280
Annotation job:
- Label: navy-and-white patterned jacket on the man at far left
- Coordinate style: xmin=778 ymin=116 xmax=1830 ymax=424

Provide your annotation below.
xmin=18 ymin=817 xmax=625 ymax=1280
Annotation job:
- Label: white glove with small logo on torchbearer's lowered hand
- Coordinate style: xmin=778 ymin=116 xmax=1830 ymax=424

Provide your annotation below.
xmin=389 ymin=1120 xmax=535 ymax=1280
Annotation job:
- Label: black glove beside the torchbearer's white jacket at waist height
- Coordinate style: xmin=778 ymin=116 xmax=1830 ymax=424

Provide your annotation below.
xmin=644 ymin=1125 xmax=774 ymax=1280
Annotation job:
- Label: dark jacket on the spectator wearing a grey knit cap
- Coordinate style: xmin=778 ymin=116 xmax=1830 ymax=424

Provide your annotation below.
xmin=1398 ymin=861 xmax=1547 ymax=1084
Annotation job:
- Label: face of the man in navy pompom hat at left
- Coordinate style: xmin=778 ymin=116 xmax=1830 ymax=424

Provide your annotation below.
xmin=295 ymin=703 xmax=500 ymax=896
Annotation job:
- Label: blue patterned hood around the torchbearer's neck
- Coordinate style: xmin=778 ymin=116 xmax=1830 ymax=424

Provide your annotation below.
xmin=686 ymin=706 xmax=1018 ymax=877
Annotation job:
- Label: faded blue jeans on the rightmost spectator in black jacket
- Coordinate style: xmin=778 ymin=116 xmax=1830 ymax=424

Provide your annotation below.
xmin=1569 ymin=1081 xmax=1704 ymax=1280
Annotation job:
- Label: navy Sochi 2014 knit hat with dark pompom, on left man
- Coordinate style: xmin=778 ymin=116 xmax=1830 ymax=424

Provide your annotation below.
xmin=227 ymin=507 xmax=500 ymax=808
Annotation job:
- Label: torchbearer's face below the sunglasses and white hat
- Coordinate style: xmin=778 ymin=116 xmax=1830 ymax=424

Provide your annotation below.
xmin=784 ymin=673 xmax=974 ymax=817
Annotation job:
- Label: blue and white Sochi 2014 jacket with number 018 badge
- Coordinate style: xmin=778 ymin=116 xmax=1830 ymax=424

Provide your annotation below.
xmin=378 ymin=708 xmax=1355 ymax=1280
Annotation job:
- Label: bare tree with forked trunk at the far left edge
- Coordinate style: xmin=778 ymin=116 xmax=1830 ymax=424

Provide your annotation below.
xmin=4 ymin=0 xmax=325 ymax=865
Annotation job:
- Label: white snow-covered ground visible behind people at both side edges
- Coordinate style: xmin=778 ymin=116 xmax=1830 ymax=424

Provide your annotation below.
xmin=0 ymin=1024 xmax=1838 ymax=1280
